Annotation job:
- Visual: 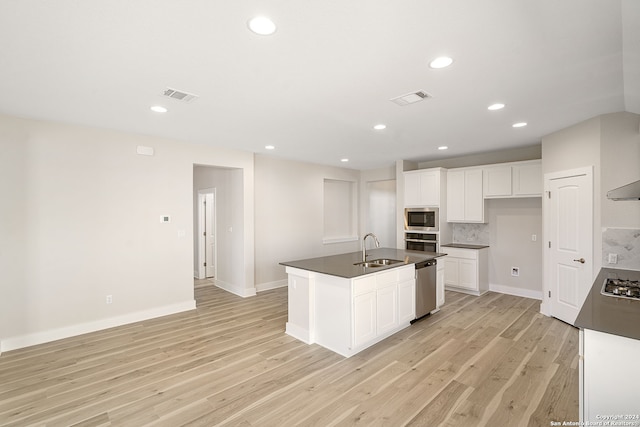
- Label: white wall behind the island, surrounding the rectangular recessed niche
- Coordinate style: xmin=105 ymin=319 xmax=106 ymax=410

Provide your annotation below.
xmin=255 ymin=155 xmax=360 ymax=290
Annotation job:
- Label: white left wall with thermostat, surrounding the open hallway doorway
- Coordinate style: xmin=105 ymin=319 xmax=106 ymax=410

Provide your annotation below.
xmin=0 ymin=115 xmax=254 ymax=351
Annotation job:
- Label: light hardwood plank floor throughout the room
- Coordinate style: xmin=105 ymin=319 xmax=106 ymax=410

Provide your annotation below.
xmin=0 ymin=282 xmax=578 ymax=427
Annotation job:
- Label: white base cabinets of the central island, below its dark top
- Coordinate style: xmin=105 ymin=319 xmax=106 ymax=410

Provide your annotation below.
xmin=286 ymin=264 xmax=415 ymax=357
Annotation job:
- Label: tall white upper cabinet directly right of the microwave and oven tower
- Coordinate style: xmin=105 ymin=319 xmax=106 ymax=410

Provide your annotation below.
xmin=447 ymin=168 xmax=484 ymax=222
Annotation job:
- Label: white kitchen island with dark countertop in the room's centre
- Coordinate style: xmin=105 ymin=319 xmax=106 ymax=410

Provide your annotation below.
xmin=280 ymin=248 xmax=444 ymax=357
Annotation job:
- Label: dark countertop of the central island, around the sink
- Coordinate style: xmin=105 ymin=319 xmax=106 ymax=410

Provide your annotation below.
xmin=280 ymin=248 xmax=446 ymax=279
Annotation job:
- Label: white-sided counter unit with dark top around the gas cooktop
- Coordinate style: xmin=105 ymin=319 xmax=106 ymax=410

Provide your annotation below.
xmin=575 ymin=268 xmax=640 ymax=426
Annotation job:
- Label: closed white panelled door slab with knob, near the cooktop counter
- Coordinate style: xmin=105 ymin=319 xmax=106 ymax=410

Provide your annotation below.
xmin=547 ymin=170 xmax=593 ymax=324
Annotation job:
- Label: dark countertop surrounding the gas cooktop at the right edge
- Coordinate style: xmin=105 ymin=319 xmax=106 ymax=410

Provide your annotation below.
xmin=575 ymin=268 xmax=640 ymax=340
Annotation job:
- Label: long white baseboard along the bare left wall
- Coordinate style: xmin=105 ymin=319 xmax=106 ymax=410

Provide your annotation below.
xmin=0 ymin=300 xmax=196 ymax=354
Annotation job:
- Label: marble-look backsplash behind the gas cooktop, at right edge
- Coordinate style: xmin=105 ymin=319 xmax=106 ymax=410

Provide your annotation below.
xmin=602 ymin=228 xmax=640 ymax=270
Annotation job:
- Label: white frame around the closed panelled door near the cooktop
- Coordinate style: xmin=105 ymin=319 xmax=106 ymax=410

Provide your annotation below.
xmin=540 ymin=166 xmax=597 ymax=317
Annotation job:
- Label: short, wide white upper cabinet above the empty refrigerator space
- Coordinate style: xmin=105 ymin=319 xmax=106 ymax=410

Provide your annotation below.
xmin=484 ymin=160 xmax=542 ymax=199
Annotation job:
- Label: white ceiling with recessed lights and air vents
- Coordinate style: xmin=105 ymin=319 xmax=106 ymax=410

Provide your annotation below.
xmin=0 ymin=0 xmax=640 ymax=169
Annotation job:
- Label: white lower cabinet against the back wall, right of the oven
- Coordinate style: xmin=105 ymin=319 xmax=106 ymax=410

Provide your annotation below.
xmin=440 ymin=247 xmax=489 ymax=295
